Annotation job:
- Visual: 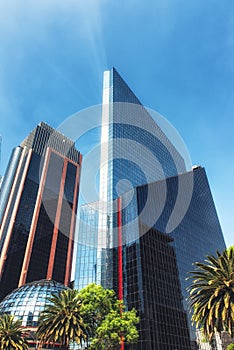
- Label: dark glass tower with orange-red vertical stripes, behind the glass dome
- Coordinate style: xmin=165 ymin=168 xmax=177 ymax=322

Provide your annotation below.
xmin=0 ymin=122 xmax=81 ymax=300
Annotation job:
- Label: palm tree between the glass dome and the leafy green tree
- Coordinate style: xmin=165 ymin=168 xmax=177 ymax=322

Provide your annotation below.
xmin=37 ymin=289 xmax=87 ymax=348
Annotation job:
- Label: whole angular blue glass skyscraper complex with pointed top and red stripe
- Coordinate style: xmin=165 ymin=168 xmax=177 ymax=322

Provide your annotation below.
xmin=75 ymin=69 xmax=225 ymax=350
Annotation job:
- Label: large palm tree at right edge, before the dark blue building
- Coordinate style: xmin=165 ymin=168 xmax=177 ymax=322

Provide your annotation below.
xmin=188 ymin=246 xmax=234 ymax=339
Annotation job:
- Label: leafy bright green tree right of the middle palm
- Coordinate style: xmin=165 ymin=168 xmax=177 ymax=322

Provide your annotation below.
xmin=79 ymin=283 xmax=139 ymax=350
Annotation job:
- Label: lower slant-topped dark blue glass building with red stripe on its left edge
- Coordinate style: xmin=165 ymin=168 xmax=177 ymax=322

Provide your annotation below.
xmin=114 ymin=167 xmax=225 ymax=349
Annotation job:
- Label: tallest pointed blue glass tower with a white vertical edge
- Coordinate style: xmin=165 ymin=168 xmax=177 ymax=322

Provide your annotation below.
xmin=97 ymin=68 xmax=186 ymax=288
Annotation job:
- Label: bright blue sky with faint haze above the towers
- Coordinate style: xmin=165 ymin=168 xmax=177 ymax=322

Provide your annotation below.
xmin=0 ymin=0 xmax=234 ymax=246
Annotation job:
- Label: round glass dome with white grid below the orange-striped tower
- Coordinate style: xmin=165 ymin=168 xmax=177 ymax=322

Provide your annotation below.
xmin=0 ymin=280 xmax=67 ymax=327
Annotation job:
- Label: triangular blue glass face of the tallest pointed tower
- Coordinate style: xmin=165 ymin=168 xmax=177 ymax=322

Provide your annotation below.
xmin=103 ymin=68 xmax=186 ymax=202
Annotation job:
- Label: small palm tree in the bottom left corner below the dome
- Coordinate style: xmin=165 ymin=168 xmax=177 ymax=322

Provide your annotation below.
xmin=0 ymin=314 xmax=28 ymax=350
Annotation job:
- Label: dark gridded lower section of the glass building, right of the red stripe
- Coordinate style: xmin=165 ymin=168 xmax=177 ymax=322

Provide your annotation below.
xmin=121 ymin=228 xmax=190 ymax=350
